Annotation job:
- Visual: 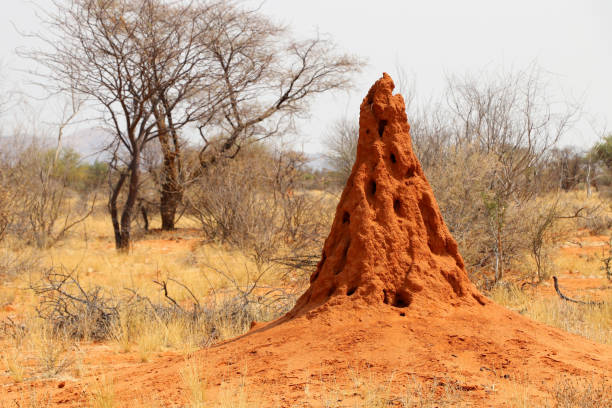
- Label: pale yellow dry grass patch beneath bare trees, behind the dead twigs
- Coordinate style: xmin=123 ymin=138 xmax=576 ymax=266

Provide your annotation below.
xmin=37 ymin=215 xmax=286 ymax=303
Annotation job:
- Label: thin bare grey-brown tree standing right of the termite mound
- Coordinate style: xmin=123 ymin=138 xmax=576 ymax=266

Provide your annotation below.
xmin=448 ymin=67 xmax=578 ymax=282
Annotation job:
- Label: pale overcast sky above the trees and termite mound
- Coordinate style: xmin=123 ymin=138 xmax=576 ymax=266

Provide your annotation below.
xmin=0 ymin=0 xmax=612 ymax=152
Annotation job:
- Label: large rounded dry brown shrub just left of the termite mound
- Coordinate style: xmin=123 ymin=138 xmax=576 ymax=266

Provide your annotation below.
xmin=187 ymin=146 xmax=331 ymax=266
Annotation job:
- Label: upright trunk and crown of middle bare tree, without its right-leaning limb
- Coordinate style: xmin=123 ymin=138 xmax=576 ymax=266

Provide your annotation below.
xmin=134 ymin=0 xmax=224 ymax=230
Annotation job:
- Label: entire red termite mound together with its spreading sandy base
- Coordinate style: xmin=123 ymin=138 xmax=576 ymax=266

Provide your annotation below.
xmin=4 ymin=74 xmax=612 ymax=407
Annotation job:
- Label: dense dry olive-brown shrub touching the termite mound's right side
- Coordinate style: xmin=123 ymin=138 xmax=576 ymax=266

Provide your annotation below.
xmin=425 ymin=144 xmax=537 ymax=289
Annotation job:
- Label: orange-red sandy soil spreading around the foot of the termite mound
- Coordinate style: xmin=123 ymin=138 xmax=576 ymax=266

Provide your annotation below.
xmin=0 ymin=302 xmax=612 ymax=407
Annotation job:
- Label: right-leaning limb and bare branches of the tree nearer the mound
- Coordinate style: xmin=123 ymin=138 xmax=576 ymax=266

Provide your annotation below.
xmin=200 ymin=4 xmax=361 ymax=166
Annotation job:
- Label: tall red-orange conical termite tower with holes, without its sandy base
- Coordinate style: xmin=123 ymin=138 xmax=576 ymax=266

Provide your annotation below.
xmin=289 ymin=73 xmax=487 ymax=317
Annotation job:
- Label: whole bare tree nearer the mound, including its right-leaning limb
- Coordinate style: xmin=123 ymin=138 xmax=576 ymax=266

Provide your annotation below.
xmin=115 ymin=0 xmax=358 ymax=230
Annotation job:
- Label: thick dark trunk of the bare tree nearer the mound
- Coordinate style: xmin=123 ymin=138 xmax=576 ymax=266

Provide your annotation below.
xmin=155 ymin=110 xmax=183 ymax=231
